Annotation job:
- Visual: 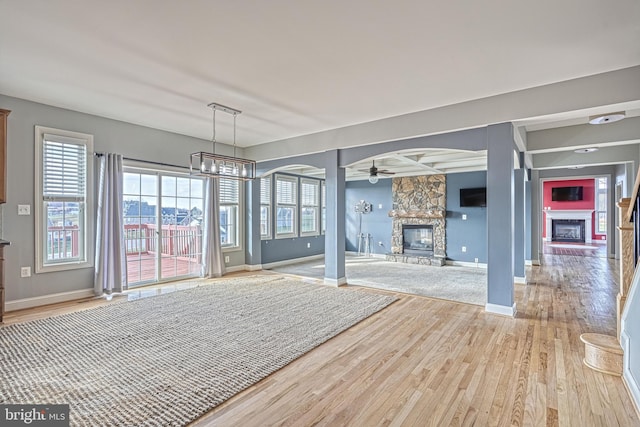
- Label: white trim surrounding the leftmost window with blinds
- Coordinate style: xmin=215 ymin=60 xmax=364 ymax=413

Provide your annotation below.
xmin=34 ymin=125 xmax=95 ymax=274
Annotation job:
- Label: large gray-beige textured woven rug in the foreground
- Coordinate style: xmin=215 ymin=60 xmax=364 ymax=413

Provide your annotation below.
xmin=0 ymin=276 xmax=395 ymax=426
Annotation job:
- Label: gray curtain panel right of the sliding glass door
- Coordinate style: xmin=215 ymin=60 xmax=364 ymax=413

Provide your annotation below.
xmin=201 ymin=178 xmax=225 ymax=278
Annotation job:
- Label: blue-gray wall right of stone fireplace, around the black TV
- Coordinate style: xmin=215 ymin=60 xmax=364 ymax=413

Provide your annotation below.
xmin=446 ymin=171 xmax=487 ymax=263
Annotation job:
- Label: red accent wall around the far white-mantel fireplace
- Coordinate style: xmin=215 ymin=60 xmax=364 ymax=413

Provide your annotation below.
xmin=542 ymin=179 xmax=606 ymax=240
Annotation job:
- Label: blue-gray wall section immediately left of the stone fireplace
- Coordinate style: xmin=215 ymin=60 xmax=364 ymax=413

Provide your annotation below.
xmin=345 ymin=179 xmax=392 ymax=254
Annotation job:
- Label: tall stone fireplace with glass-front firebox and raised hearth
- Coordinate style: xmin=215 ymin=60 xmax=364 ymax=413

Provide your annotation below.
xmin=386 ymin=175 xmax=447 ymax=265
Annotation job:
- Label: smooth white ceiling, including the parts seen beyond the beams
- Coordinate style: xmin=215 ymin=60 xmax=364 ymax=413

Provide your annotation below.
xmin=0 ymin=0 xmax=640 ymax=177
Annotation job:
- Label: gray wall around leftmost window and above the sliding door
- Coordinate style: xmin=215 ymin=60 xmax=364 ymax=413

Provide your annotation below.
xmin=0 ymin=95 xmax=244 ymax=301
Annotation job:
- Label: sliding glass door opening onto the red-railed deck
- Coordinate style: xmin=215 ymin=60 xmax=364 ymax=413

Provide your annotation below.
xmin=123 ymin=168 xmax=204 ymax=286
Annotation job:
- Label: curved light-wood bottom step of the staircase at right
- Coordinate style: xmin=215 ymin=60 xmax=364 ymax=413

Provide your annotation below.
xmin=580 ymin=333 xmax=622 ymax=376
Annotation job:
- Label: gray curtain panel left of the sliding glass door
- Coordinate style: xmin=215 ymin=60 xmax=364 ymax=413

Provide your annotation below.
xmin=94 ymin=153 xmax=127 ymax=298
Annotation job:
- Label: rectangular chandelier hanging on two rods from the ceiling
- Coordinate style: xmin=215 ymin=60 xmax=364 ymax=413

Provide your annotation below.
xmin=189 ymin=102 xmax=256 ymax=181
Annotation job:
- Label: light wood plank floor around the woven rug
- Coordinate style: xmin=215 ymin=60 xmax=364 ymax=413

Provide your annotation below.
xmin=5 ymin=254 xmax=640 ymax=427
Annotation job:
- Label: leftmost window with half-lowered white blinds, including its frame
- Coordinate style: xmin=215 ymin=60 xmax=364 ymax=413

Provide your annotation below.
xmin=35 ymin=126 xmax=93 ymax=273
